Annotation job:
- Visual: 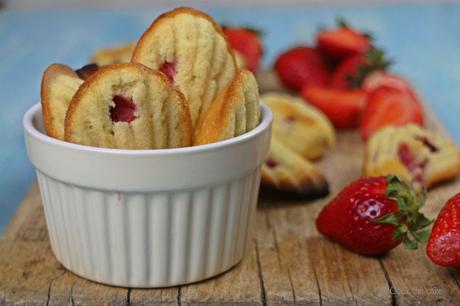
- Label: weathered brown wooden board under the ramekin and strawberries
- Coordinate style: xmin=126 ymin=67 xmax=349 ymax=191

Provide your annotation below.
xmin=0 ymin=75 xmax=460 ymax=305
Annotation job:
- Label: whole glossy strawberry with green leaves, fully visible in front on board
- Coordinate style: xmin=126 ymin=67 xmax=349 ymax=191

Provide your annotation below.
xmin=316 ymin=176 xmax=431 ymax=255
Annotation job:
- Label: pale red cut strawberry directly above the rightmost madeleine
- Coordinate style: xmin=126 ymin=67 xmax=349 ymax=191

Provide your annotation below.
xmin=359 ymin=86 xmax=424 ymax=139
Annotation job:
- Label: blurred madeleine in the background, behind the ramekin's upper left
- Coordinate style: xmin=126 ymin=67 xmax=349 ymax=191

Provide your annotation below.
xmin=91 ymin=43 xmax=136 ymax=66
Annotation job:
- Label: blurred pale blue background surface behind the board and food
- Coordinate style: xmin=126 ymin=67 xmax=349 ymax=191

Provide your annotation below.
xmin=0 ymin=4 xmax=460 ymax=233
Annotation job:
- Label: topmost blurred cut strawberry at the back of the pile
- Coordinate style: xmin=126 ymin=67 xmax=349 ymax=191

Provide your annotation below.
xmin=316 ymin=27 xmax=371 ymax=57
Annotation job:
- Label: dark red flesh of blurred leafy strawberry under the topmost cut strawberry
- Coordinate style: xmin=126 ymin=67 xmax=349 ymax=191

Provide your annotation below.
xmin=329 ymin=54 xmax=366 ymax=89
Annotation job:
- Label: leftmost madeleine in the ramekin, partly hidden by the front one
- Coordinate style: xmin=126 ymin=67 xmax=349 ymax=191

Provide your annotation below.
xmin=41 ymin=64 xmax=83 ymax=140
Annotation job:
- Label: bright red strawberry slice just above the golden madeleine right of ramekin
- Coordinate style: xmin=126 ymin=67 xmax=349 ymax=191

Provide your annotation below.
xmin=301 ymin=86 xmax=366 ymax=128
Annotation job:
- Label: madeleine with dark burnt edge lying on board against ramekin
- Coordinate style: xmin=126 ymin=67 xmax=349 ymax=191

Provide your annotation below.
xmin=261 ymin=137 xmax=329 ymax=197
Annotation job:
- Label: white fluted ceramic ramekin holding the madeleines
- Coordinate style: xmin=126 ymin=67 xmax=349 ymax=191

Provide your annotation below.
xmin=23 ymin=104 xmax=272 ymax=287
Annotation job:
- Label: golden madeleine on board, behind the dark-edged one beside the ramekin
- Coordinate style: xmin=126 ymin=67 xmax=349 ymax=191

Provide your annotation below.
xmin=260 ymin=92 xmax=335 ymax=159
